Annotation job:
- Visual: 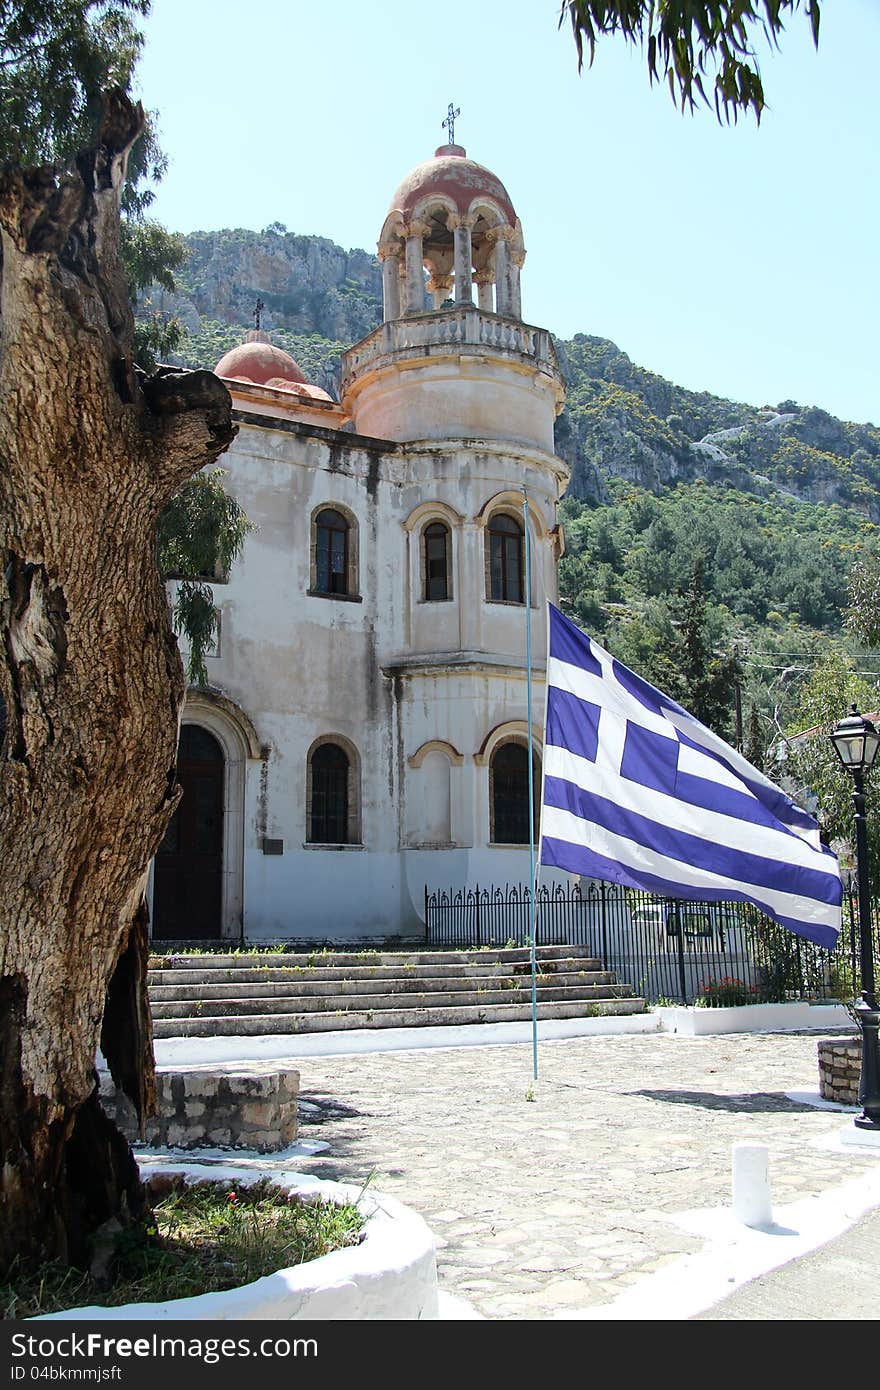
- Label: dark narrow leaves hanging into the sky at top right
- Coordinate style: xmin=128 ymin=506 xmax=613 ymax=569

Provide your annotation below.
xmin=559 ymin=0 xmax=820 ymax=121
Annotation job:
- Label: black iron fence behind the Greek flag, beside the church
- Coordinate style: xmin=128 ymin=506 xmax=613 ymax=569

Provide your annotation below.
xmin=425 ymin=883 xmax=880 ymax=1006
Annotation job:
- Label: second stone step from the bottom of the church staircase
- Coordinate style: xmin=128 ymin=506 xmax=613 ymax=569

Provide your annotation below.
xmin=153 ymin=984 xmax=631 ymax=1019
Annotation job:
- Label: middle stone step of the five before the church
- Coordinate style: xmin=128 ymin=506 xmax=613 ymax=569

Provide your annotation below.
xmin=150 ymin=962 xmax=616 ymax=1004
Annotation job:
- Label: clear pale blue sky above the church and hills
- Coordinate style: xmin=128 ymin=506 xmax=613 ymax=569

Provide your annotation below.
xmin=139 ymin=0 xmax=880 ymax=424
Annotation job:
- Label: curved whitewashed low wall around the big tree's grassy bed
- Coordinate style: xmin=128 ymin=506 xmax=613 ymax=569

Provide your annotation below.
xmin=39 ymin=1163 xmax=438 ymax=1322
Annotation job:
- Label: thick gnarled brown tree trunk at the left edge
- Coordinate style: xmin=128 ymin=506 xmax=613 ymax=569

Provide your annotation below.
xmin=0 ymin=93 xmax=235 ymax=1270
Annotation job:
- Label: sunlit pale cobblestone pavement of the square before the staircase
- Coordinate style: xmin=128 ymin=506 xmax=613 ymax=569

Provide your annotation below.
xmin=286 ymin=1034 xmax=877 ymax=1318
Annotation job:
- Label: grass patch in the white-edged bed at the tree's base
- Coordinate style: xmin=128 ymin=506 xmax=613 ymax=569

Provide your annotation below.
xmin=0 ymin=1175 xmax=363 ymax=1319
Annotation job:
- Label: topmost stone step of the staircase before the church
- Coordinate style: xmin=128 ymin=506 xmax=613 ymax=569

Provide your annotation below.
xmin=150 ymin=945 xmax=595 ymax=977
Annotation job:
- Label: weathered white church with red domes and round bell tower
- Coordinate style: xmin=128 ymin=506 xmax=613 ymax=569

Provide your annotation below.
xmin=150 ymin=143 xmax=569 ymax=944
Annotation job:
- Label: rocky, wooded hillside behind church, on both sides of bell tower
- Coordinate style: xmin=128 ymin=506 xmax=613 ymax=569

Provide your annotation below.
xmin=143 ymin=224 xmax=880 ymax=760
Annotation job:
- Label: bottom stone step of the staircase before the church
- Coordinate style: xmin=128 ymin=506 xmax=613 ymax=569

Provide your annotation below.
xmin=153 ymin=997 xmax=646 ymax=1038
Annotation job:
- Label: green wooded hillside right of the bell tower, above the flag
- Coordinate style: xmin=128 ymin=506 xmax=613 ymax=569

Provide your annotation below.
xmin=557 ymin=334 xmax=880 ymax=762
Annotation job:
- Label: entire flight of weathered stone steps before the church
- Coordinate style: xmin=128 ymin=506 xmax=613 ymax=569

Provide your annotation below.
xmin=149 ymin=947 xmax=646 ymax=1038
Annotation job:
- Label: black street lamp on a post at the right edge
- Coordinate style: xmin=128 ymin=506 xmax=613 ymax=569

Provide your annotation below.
xmin=830 ymin=705 xmax=880 ymax=1134
